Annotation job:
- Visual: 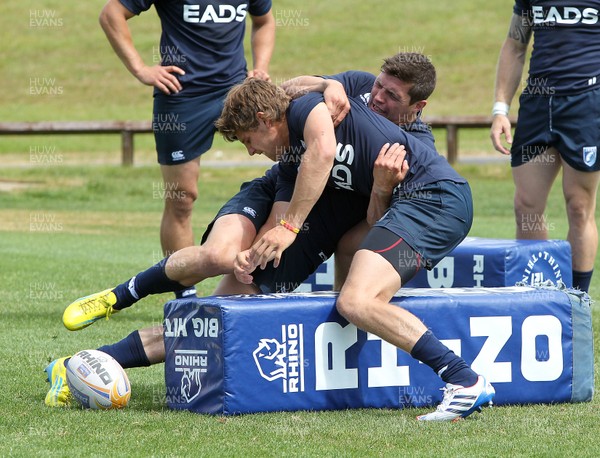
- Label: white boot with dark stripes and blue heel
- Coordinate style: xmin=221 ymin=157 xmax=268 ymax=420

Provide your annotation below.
xmin=417 ymin=375 xmax=496 ymax=421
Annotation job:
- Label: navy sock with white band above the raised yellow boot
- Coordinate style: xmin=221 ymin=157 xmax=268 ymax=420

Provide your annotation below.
xmin=113 ymin=257 xmax=188 ymax=310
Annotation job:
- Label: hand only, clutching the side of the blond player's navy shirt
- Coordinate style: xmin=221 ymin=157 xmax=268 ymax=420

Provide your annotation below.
xmin=373 ymin=143 xmax=408 ymax=194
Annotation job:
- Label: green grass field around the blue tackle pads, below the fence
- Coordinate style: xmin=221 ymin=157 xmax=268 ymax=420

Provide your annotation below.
xmin=0 ymin=165 xmax=600 ymax=457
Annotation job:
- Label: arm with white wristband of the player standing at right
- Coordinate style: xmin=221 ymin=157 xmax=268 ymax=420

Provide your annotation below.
xmin=490 ymin=14 xmax=532 ymax=154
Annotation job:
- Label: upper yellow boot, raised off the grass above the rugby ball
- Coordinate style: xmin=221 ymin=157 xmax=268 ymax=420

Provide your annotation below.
xmin=63 ymin=289 xmax=118 ymax=331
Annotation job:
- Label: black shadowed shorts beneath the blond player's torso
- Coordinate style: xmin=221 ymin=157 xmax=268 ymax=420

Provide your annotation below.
xmin=252 ymin=188 xmax=369 ymax=294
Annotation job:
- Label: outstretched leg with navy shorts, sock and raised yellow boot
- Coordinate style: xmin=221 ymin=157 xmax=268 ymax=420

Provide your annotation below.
xmin=63 ymin=165 xmax=278 ymax=331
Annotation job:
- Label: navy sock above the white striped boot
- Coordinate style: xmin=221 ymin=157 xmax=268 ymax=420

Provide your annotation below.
xmin=410 ymin=331 xmax=478 ymax=386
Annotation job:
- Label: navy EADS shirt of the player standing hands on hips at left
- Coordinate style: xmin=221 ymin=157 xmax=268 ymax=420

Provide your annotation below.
xmin=119 ymin=0 xmax=271 ymax=96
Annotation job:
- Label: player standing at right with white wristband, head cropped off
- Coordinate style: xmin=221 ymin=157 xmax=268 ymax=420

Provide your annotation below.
xmin=491 ymin=0 xmax=600 ymax=292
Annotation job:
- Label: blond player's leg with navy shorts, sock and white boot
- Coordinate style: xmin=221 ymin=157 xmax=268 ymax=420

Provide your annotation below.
xmin=336 ymin=181 xmax=495 ymax=420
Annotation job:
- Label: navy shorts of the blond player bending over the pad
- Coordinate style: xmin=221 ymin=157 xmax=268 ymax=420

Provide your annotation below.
xmin=361 ymin=180 xmax=473 ymax=270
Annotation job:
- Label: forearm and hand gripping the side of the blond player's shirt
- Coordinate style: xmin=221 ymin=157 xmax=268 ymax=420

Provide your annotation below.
xmin=367 ymin=143 xmax=408 ymax=226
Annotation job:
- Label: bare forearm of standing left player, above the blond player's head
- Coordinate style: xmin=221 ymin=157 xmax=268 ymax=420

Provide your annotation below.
xmin=248 ymin=10 xmax=275 ymax=81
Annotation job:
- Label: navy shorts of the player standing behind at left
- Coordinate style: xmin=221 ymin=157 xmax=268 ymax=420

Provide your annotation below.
xmin=152 ymin=88 xmax=229 ymax=165
